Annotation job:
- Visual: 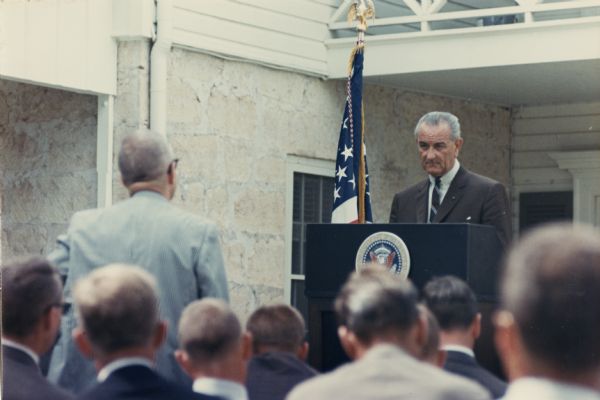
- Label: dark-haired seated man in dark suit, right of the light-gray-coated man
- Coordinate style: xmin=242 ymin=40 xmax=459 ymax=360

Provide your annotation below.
xmin=423 ymin=276 xmax=506 ymax=399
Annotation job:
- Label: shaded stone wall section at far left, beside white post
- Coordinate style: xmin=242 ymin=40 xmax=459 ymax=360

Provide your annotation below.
xmin=0 ymin=80 xmax=97 ymax=261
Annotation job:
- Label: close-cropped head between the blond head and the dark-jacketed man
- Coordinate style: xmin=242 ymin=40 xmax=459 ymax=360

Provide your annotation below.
xmin=179 ymin=298 xmax=242 ymax=367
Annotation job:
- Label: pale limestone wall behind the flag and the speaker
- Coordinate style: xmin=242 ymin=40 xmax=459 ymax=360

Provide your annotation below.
xmin=168 ymin=49 xmax=510 ymax=316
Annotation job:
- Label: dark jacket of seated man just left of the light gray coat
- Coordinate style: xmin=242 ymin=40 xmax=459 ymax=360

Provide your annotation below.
xmin=246 ymin=352 xmax=318 ymax=400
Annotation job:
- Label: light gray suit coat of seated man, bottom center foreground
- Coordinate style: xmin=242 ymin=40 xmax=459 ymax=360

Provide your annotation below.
xmin=286 ymin=344 xmax=490 ymax=400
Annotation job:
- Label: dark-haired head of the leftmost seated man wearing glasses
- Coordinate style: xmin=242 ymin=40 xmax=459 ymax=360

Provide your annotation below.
xmin=2 ymin=258 xmax=62 ymax=338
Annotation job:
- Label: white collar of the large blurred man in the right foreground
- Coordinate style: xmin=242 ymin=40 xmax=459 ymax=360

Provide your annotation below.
xmin=504 ymin=377 xmax=600 ymax=400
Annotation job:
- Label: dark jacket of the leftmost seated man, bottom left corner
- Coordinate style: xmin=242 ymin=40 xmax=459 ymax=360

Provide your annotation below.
xmin=1 ymin=346 xmax=75 ymax=400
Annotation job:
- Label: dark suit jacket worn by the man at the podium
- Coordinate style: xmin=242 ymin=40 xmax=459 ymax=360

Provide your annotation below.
xmin=390 ymin=166 xmax=512 ymax=245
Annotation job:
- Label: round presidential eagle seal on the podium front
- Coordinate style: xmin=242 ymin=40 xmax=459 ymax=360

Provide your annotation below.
xmin=356 ymin=232 xmax=410 ymax=279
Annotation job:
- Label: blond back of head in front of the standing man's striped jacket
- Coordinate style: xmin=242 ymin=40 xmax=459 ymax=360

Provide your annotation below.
xmin=74 ymin=264 xmax=159 ymax=355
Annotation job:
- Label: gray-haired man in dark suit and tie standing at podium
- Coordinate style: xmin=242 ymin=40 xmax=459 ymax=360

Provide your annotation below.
xmin=390 ymin=111 xmax=511 ymax=245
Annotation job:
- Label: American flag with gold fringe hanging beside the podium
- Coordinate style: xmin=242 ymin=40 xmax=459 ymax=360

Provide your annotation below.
xmin=331 ymin=48 xmax=373 ymax=223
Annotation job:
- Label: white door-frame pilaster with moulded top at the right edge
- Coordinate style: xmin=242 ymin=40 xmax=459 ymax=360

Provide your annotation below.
xmin=549 ymin=151 xmax=600 ymax=227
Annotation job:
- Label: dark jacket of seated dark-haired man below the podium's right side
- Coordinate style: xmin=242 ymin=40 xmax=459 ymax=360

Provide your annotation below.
xmin=444 ymin=351 xmax=507 ymax=399
